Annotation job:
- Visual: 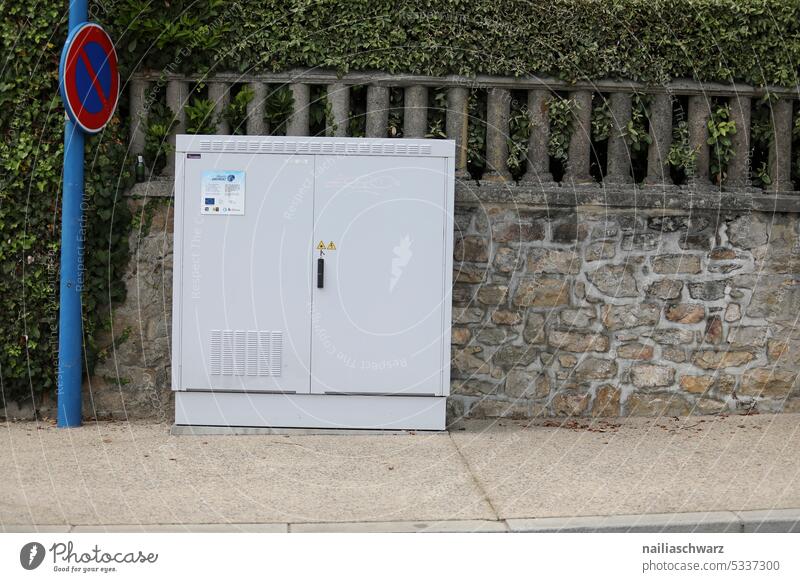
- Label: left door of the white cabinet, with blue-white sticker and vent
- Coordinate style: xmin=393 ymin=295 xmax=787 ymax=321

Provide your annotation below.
xmin=174 ymin=153 xmax=314 ymax=393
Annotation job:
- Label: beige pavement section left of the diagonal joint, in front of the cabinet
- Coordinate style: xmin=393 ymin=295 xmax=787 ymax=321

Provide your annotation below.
xmin=0 ymin=422 xmax=495 ymax=525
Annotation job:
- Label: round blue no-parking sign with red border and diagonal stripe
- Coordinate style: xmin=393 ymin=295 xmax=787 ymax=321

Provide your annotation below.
xmin=59 ymin=22 xmax=119 ymax=133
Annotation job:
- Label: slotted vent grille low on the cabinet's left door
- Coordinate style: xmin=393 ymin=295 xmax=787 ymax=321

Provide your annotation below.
xmin=208 ymin=329 xmax=283 ymax=376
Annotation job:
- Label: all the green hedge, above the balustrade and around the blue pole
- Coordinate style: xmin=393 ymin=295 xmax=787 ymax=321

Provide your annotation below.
xmin=0 ymin=0 xmax=800 ymax=407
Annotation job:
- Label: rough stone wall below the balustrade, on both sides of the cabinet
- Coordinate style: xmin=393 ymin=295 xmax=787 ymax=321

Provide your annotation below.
xmin=84 ymin=185 xmax=800 ymax=420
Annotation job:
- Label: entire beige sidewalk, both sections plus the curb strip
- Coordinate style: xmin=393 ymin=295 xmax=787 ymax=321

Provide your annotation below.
xmin=0 ymin=414 xmax=800 ymax=532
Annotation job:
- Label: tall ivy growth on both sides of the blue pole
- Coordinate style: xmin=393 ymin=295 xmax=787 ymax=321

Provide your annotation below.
xmin=0 ymin=0 xmax=130 ymax=408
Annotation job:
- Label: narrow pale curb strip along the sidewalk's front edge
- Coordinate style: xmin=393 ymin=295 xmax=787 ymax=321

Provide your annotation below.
xmin=0 ymin=509 xmax=800 ymax=533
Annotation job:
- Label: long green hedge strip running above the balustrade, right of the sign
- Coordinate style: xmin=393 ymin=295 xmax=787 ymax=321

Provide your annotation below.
xmin=109 ymin=0 xmax=800 ymax=85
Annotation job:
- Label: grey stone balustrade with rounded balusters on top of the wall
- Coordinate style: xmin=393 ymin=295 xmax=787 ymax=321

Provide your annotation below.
xmin=130 ymin=69 xmax=800 ymax=192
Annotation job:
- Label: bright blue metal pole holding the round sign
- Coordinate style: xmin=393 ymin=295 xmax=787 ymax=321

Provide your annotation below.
xmin=57 ymin=0 xmax=88 ymax=428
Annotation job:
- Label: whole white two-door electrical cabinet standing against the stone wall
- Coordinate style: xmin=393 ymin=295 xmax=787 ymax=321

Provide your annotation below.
xmin=172 ymin=135 xmax=454 ymax=430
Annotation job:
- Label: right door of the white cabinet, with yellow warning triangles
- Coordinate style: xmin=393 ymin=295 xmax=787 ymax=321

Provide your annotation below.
xmin=311 ymin=156 xmax=449 ymax=395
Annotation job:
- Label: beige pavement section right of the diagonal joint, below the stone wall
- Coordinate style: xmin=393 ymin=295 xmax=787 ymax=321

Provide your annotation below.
xmin=451 ymin=414 xmax=800 ymax=519
